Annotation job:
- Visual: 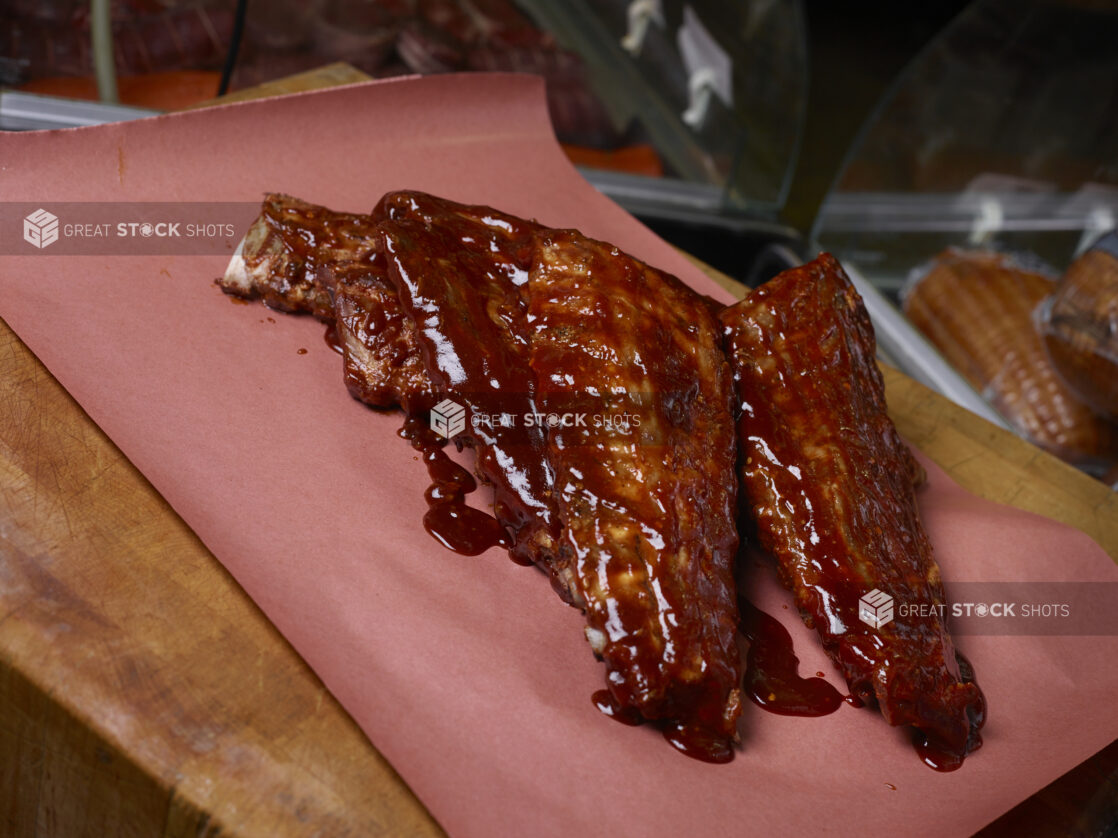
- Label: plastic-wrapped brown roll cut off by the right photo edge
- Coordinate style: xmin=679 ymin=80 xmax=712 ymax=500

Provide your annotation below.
xmin=1036 ymin=230 xmax=1118 ymax=419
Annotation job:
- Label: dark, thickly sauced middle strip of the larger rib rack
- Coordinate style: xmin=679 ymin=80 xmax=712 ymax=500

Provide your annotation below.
xmin=373 ymin=192 xmax=567 ymax=589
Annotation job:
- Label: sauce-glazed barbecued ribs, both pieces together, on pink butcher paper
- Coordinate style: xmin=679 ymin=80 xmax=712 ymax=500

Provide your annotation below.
xmin=218 ymin=191 xmax=985 ymax=768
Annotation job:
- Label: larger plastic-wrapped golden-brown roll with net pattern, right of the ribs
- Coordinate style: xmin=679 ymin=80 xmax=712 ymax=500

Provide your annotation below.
xmin=902 ymin=249 xmax=1118 ymax=472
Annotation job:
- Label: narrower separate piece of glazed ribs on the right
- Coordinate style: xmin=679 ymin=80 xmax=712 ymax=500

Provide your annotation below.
xmin=721 ymin=254 xmax=985 ymax=760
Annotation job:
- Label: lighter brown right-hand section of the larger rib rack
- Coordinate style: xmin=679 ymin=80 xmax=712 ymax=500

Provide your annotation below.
xmin=528 ymin=230 xmax=741 ymax=762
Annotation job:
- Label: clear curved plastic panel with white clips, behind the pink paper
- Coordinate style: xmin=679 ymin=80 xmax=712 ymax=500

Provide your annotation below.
xmin=519 ymin=0 xmax=807 ymax=221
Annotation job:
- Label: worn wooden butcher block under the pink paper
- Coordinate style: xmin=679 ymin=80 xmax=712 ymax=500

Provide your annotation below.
xmin=0 ymin=69 xmax=1118 ymax=838
